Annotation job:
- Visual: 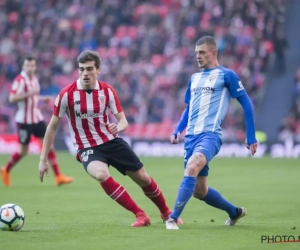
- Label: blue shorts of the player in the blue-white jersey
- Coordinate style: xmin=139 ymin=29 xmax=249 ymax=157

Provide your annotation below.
xmin=184 ymin=132 xmax=222 ymax=176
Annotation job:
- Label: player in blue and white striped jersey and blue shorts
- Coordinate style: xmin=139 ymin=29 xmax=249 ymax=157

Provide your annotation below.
xmin=166 ymin=36 xmax=257 ymax=229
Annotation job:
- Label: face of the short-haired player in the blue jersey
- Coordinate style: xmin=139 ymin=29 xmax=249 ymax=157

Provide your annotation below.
xmin=195 ymin=44 xmax=217 ymax=69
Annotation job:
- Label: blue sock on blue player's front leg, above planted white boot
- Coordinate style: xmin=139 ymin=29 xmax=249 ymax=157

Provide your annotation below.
xmin=170 ymin=176 xmax=196 ymax=220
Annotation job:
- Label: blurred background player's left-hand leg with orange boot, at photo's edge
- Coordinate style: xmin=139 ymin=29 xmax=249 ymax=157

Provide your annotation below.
xmin=1 ymin=124 xmax=31 ymax=187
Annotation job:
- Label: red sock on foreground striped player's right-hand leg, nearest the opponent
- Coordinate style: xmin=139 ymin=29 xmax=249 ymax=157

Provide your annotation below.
xmin=142 ymin=177 xmax=170 ymax=213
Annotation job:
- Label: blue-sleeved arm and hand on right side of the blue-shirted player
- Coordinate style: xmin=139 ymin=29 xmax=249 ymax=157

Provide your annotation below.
xmin=237 ymin=93 xmax=257 ymax=155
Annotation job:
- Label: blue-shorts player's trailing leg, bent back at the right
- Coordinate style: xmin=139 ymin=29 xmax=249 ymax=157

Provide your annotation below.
xmin=193 ymin=175 xmax=247 ymax=226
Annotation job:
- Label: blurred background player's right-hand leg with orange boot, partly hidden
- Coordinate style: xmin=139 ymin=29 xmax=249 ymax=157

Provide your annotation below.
xmin=33 ymin=121 xmax=73 ymax=186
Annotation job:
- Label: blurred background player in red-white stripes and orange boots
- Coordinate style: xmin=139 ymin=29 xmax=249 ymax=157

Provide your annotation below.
xmin=1 ymin=57 xmax=73 ymax=186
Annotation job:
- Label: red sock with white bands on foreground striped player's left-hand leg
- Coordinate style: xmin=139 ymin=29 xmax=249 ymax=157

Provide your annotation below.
xmin=101 ymin=177 xmax=144 ymax=214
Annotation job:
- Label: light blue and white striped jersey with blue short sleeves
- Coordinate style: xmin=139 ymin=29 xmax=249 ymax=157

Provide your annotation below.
xmin=185 ymin=66 xmax=246 ymax=139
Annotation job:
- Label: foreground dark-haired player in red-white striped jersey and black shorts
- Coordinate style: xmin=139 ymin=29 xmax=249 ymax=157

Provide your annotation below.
xmin=39 ymin=51 xmax=183 ymax=227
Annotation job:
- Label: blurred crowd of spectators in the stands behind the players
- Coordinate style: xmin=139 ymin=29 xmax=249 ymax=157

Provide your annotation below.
xmin=0 ymin=0 xmax=290 ymax=139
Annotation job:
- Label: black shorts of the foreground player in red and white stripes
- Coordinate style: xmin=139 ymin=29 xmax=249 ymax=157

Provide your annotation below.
xmin=76 ymin=138 xmax=143 ymax=175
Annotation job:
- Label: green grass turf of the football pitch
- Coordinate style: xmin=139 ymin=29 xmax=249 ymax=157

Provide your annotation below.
xmin=0 ymin=153 xmax=300 ymax=250
